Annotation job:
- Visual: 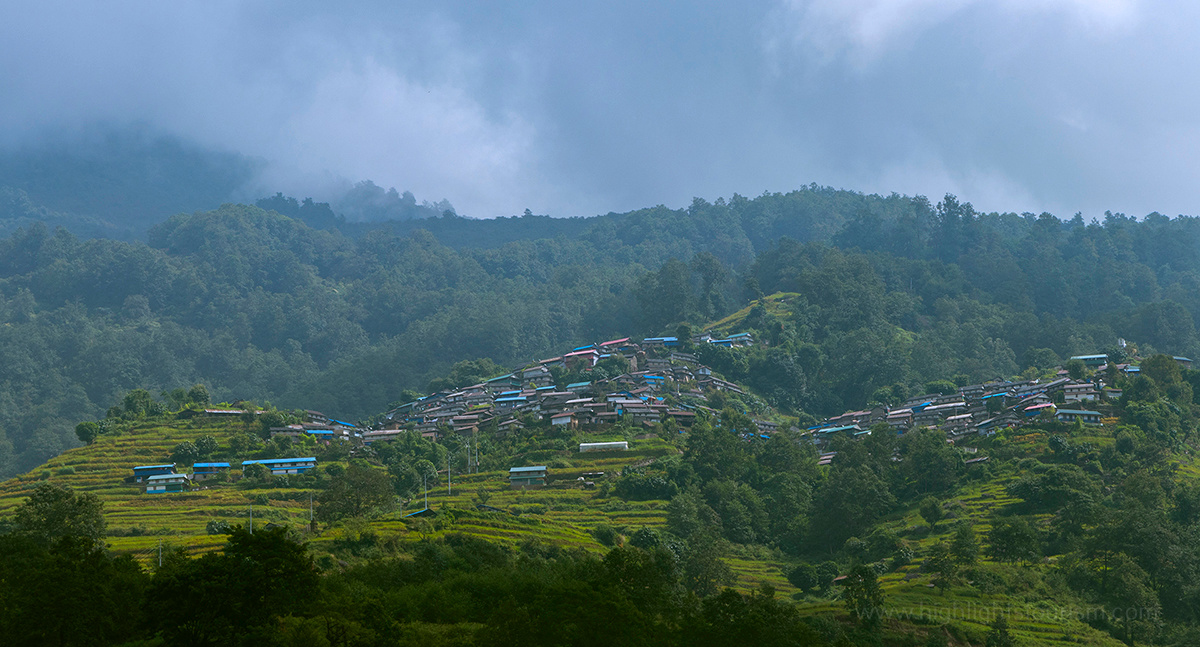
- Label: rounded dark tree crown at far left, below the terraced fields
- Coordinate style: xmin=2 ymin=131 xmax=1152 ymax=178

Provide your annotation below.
xmin=13 ymin=483 xmax=106 ymax=546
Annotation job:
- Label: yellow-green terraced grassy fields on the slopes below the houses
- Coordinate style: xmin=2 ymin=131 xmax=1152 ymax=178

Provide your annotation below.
xmin=0 ymin=419 xmax=1137 ymax=646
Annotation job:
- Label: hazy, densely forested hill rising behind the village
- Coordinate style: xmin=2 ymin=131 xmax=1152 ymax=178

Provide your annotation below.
xmin=0 ymin=186 xmax=1200 ymax=477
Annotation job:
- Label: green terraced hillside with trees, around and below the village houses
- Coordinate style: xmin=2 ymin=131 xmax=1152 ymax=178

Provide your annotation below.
xmin=0 ymin=326 xmax=1200 ymax=645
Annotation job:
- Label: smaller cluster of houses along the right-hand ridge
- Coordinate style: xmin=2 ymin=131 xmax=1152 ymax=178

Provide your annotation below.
xmin=805 ymin=355 xmax=1166 ymax=448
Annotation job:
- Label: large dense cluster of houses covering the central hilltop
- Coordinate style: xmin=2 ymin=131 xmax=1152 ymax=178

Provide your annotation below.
xmin=361 ymin=333 xmax=776 ymax=444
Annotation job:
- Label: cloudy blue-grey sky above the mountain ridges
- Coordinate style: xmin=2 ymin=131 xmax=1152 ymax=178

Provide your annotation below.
xmin=0 ymin=0 xmax=1200 ymax=218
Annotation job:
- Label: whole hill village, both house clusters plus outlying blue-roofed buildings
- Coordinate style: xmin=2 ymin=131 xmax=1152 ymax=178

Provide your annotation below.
xmin=132 ymin=333 xmax=1171 ymax=493
